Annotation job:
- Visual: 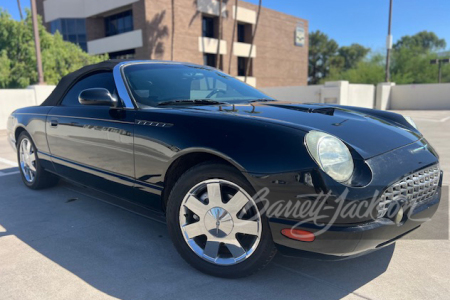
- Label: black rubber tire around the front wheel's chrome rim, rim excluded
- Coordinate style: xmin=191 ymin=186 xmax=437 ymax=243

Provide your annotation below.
xmin=166 ymin=163 xmax=274 ymax=278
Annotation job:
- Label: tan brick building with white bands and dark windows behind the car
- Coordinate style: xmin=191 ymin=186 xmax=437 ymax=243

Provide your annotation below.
xmin=37 ymin=0 xmax=308 ymax=87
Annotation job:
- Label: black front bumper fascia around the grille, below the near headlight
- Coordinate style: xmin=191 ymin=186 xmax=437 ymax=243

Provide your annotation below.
xmin=244 ymin=140 xmax=443 ymax=258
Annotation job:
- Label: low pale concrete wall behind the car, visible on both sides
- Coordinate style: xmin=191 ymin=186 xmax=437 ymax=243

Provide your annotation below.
xmin=0 ymin=81 xmax=450 ymax=130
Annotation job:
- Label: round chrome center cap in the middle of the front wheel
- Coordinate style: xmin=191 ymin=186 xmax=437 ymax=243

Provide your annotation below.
xmin=205 ymin=207 xmax=234 ymax=238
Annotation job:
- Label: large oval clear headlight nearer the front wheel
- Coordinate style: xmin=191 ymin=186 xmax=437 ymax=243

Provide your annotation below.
xmin=305 ymin=130 xmax=354 ymax=182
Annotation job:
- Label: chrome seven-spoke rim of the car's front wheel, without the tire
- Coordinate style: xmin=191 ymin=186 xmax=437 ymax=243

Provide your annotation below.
xmin=179 ymin=179 xmax=262 ymax=265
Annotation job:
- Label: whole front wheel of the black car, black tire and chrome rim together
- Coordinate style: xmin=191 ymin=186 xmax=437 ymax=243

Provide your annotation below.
xmin=166 ymin=162 xmax=276 ymax=278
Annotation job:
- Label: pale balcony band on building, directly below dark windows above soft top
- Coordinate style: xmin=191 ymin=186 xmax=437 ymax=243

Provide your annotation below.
xmin=87 ymin=29 xmax=143 ymax=54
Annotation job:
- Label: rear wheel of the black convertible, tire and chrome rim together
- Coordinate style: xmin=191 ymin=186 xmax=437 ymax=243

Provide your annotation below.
xmin=17 ymin=131 xmax=59 ymax=190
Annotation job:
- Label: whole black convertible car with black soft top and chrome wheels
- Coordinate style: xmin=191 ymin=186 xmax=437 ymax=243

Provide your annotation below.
xmin=8 ymin=60 xmax=442 ymax=277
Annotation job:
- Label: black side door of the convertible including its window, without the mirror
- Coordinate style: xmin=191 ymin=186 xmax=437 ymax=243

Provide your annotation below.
xmin=46 ymin=72 xmax=135 ymax=196
